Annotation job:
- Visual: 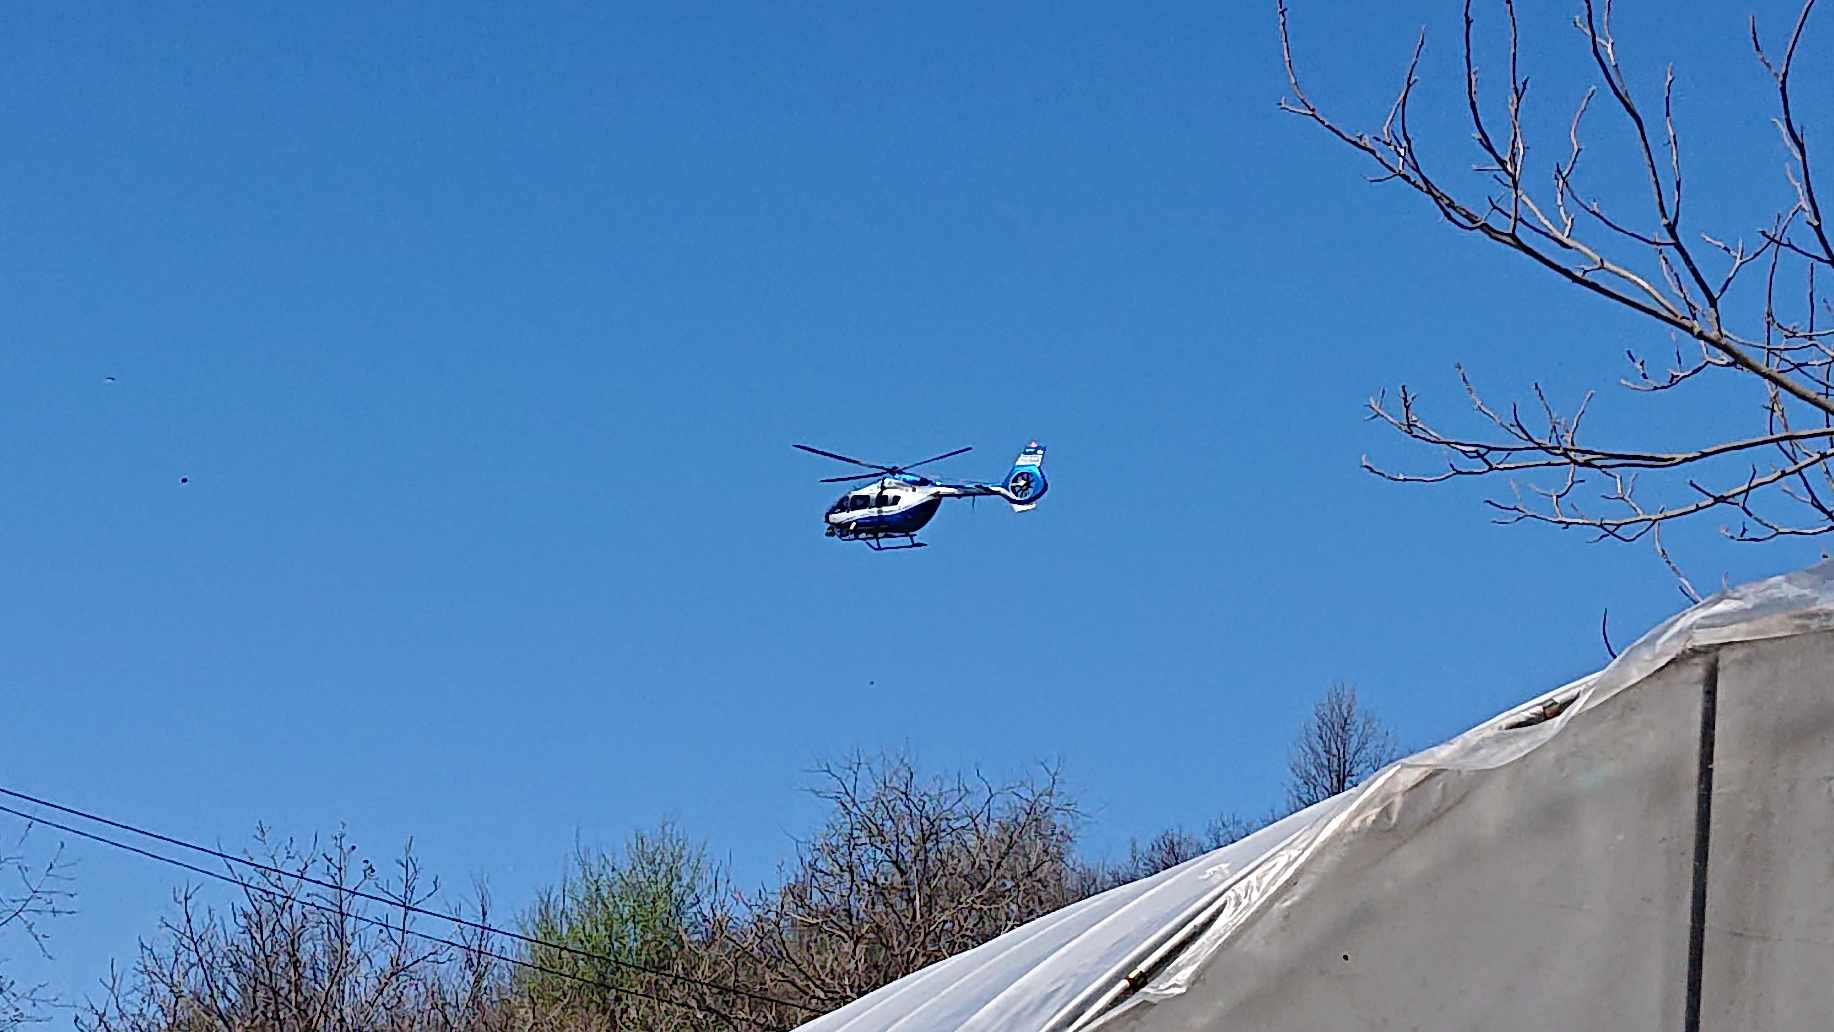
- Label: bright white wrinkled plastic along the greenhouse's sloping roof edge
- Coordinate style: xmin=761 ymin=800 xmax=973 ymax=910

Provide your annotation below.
xmin=801 ymin=563 xmax=1834 ymax=1032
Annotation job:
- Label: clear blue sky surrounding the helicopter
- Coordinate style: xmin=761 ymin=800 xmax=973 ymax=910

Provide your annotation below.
xmin=0 ymin=0 xmax=1834 ymax=1019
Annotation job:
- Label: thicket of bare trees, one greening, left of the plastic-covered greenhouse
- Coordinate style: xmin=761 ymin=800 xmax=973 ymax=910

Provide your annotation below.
xmin=64 ymin=755 xmax=1298 ymax=1032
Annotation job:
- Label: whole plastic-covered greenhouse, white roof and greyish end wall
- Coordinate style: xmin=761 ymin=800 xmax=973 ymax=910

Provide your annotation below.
xmin=801 ymin=563 xmax=1834 ymax=1032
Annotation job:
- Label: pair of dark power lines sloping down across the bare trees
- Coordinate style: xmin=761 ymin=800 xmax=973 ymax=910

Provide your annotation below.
xmin=0 ymin=786 xmax=820 ymax=1014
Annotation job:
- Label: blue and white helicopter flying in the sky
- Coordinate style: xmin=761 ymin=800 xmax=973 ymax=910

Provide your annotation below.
xmin=796 ymin=442 xmax=1051 ymax=552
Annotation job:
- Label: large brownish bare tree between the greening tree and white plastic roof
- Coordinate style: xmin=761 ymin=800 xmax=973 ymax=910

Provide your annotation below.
xmin=726 ymin=755 xmax=1078 ymax=1010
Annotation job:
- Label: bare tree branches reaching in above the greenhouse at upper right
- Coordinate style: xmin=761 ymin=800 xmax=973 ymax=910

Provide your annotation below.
xmin=1276 ymin=0 xmax=1834 ymax=598
